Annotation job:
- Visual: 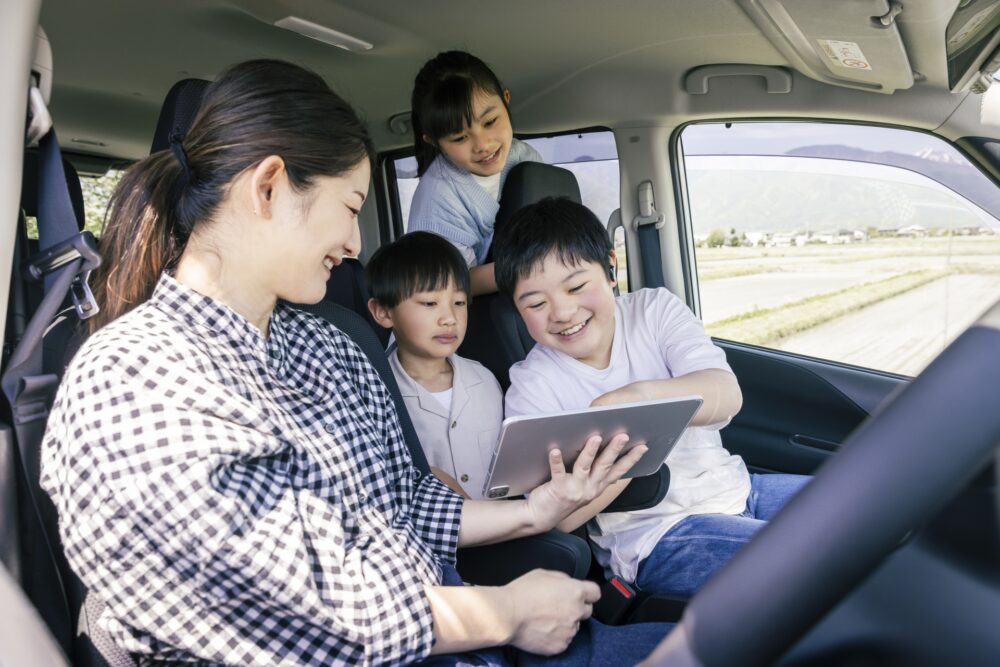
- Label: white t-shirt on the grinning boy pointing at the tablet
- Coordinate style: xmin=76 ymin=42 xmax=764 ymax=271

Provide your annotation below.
xmin=505 ymin=288 xmax=750 ymax=581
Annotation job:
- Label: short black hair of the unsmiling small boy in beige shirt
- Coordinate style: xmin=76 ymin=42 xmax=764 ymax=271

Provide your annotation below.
xmin=365 ymin=232 xmax=470 ymax=308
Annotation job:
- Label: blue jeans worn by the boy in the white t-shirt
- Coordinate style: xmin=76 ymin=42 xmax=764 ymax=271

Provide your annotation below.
xmin=635 ymin=474 xmax=812 ymax=597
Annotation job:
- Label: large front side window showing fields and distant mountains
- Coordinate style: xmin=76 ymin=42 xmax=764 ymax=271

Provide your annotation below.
xmin=680 ymin=122 xmax=1000 ymax=375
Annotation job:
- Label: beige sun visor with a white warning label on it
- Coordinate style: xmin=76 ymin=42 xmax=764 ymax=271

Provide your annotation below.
xmin=739 ymin=0 xmax=913 ymax=93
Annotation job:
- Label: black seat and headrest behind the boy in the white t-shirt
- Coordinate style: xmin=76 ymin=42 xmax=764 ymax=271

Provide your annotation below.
xmin=458 ymin=162 xmax=581 ymax=390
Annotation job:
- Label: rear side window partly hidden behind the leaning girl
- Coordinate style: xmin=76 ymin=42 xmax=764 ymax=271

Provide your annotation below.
xmin=391 ymin=130 xmax=628 ymax=292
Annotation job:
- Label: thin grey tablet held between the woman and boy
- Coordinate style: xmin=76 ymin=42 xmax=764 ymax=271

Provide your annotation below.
xmin=483 ymin=396 xmax=702 ymax=498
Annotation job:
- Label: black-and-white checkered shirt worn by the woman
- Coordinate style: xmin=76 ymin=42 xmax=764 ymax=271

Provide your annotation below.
xmin=42 ymin=276 xmax=462 ymax=665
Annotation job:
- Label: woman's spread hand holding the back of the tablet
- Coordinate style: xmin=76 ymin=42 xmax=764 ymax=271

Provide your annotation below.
xmin=528 ymin=433 xmax=648 ymax=531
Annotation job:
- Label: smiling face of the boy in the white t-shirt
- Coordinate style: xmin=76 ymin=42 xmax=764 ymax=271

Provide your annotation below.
xmin=514 ymin=252 xmax=615 ymax=368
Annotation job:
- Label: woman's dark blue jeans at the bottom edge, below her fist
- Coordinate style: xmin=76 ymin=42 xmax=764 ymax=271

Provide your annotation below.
xmin=419 ymin=566 xmax=673 ymax=667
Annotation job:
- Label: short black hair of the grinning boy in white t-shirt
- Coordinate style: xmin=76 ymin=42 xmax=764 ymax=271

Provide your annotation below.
xmin=493 ymin=197 xmax=611 ymax=298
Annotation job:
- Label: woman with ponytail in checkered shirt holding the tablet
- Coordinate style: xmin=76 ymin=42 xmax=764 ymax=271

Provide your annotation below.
xmin=42 ymin=61 xmax=662 ymax=665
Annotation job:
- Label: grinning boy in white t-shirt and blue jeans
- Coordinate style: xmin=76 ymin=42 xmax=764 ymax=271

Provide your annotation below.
xmin=493 ymin=199 xmax=809 ymax=596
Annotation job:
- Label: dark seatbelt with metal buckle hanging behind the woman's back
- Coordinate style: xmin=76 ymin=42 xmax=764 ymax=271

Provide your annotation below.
xmin=0 ymin=74 xmax=101 ymax=655
